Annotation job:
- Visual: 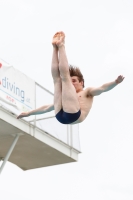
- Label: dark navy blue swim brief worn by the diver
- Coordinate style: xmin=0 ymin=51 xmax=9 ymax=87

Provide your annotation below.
xmin=56 ymin=109 xmax=81 ymax=124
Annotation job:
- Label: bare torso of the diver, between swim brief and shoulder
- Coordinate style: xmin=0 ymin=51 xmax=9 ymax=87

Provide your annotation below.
xmin=72 ymin=90 xmax=93 ymax=124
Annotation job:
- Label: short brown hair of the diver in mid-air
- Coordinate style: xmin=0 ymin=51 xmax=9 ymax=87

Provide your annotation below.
xmin=69 ymin=64 xmax=84 ymax=87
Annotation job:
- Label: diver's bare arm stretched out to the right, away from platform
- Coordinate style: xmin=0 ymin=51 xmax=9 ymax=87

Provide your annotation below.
xmin=87 ymin=75 xmax=124 ymax=96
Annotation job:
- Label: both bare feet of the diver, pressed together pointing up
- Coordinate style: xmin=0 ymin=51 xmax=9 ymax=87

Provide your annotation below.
xmin=52 ymin=31 xmax=65 ymax=47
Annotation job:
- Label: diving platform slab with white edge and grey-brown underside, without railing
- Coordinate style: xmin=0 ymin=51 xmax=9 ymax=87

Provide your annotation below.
xmin=0 ymin=106 xmax=81 ymax=171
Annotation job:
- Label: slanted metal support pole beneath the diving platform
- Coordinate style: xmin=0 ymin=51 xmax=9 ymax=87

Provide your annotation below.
xmin=0 ymin=134 xmax=20 ymax=174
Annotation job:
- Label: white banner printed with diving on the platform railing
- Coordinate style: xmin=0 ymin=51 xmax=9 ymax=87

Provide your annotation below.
xmin=0 ymin=59 xmax=35 ymax=112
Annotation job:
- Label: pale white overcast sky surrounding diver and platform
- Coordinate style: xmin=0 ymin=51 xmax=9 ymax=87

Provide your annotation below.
xmin=0 ymin=0 xmax=133 ymax=200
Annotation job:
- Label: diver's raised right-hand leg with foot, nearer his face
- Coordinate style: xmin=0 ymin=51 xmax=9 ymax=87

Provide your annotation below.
xmin=56 ymin=32 xmax=80 ymax=113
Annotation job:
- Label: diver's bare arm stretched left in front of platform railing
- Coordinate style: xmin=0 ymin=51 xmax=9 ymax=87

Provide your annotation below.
xmin=17 ymin=104 xmax=54 ymax=119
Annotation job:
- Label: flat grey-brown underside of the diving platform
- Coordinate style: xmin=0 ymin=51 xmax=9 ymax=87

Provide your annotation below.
xmin=0 ymin=119 xmax=76 ymax=170
